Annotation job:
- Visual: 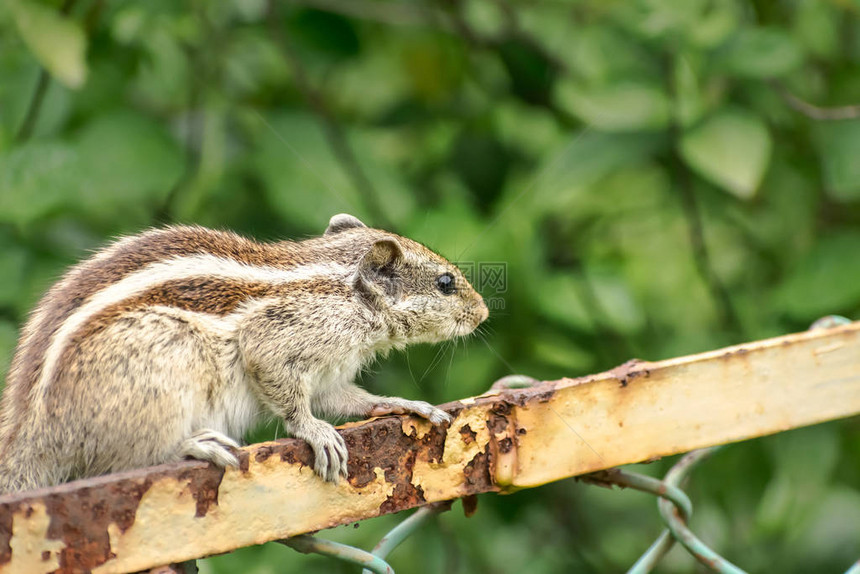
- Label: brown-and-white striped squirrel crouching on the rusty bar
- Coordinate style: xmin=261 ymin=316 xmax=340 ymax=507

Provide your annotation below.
xmin=0 ymin=214 xmax=488 ymax=492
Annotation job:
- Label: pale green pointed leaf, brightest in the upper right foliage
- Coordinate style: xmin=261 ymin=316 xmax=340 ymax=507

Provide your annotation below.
xmin=681 ymin=110 xmax=772 ymax=199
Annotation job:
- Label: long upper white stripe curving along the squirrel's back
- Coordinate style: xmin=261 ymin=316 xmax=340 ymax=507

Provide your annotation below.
xmin=37 ymin=254 xmax=350 ymax=396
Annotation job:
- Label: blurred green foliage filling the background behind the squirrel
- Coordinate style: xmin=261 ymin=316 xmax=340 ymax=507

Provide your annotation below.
xmin=0 ymin=0 xmax=860 ymax=573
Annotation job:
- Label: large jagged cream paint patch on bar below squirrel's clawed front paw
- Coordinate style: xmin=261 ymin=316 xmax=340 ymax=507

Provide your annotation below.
xmin=91 ymin=464 xmax=394 ymax=573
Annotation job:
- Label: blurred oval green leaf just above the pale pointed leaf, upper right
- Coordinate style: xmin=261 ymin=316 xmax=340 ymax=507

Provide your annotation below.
xmin=723 ymin=28 xmax=803 ymax=78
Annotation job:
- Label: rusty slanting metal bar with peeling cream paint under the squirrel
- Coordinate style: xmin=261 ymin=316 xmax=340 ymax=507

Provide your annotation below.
xmin=0 ymin=323 xmax=860 ymax=572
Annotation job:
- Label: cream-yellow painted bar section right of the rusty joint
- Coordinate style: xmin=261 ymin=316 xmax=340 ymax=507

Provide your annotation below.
xmin=511 ymin=323 xmax=860 ymax=488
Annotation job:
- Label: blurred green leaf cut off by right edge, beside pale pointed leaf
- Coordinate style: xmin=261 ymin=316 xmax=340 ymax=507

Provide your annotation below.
xmin=814 ymin=120 xmax=860 ymax=201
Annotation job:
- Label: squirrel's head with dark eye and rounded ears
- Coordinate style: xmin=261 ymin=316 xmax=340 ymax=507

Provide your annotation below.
xmin=326 ymin=214 xmax=489 ymax=343
